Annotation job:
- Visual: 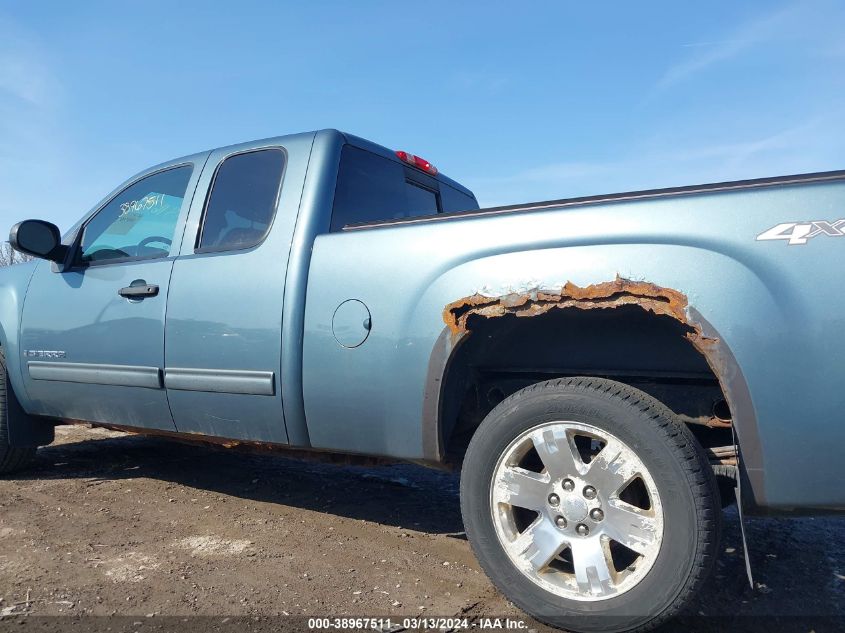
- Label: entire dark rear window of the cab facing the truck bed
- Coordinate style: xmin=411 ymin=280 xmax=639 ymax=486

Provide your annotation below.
xmin=330 ymin=145 xmax=478 ymax=232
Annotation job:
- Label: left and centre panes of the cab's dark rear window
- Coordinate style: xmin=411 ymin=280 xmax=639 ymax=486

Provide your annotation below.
xmin=331 ymin=145 xmax=438 ymax=231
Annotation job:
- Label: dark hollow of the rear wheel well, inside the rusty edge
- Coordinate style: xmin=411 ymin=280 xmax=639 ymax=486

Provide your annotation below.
xmin=440 ymin=305 xmax=733 ymax=462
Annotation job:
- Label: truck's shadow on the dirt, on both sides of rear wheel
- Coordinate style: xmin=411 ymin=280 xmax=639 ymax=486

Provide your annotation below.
xmin=18 ymin=436 xmax=845 ymax=633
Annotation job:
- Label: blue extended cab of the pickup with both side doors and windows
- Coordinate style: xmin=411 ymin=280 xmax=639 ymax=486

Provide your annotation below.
xmin=3 ymin=130 xmax=478 ymax=445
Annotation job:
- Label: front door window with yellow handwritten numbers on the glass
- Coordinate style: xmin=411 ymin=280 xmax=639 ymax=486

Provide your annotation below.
xmin=80 ymin=165 xmax=193 ymax=263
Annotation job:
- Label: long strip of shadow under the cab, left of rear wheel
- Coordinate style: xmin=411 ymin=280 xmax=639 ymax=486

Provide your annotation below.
xmin=23 ymin=435 xmax=463 ymax=537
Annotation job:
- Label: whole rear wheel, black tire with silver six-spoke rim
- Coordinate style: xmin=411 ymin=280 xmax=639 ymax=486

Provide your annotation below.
xmin=461 ymin=378 xmax=720 ymax=631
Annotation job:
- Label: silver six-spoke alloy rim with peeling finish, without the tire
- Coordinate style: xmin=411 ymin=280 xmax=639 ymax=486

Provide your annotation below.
xmin=490 ymin=421 xmax=663 ymax=601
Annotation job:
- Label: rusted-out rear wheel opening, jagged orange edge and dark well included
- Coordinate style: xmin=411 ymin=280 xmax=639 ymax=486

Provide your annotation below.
xmin=436 ymin=275 xmax=762 ymax=498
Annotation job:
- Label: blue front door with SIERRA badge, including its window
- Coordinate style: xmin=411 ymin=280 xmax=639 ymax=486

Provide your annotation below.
xmin=20 ymin=155 xmax=206 ymax=430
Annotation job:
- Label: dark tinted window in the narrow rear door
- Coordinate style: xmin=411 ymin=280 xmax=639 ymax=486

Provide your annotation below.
xmin=197 ymin=149 xmax=285 ymax=251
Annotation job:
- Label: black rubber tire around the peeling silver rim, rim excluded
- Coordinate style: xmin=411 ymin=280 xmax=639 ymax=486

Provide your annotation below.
xmin=461 ymin=378 xmax=721 ymax=632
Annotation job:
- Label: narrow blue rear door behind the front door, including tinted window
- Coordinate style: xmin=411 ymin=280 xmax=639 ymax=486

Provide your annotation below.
xmin=165 ymin=141 xmax=310 ymax=443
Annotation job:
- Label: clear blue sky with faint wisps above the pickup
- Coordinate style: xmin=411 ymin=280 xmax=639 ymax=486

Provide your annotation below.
xmin=0 ymin=0 xmax=845 ymax=231
